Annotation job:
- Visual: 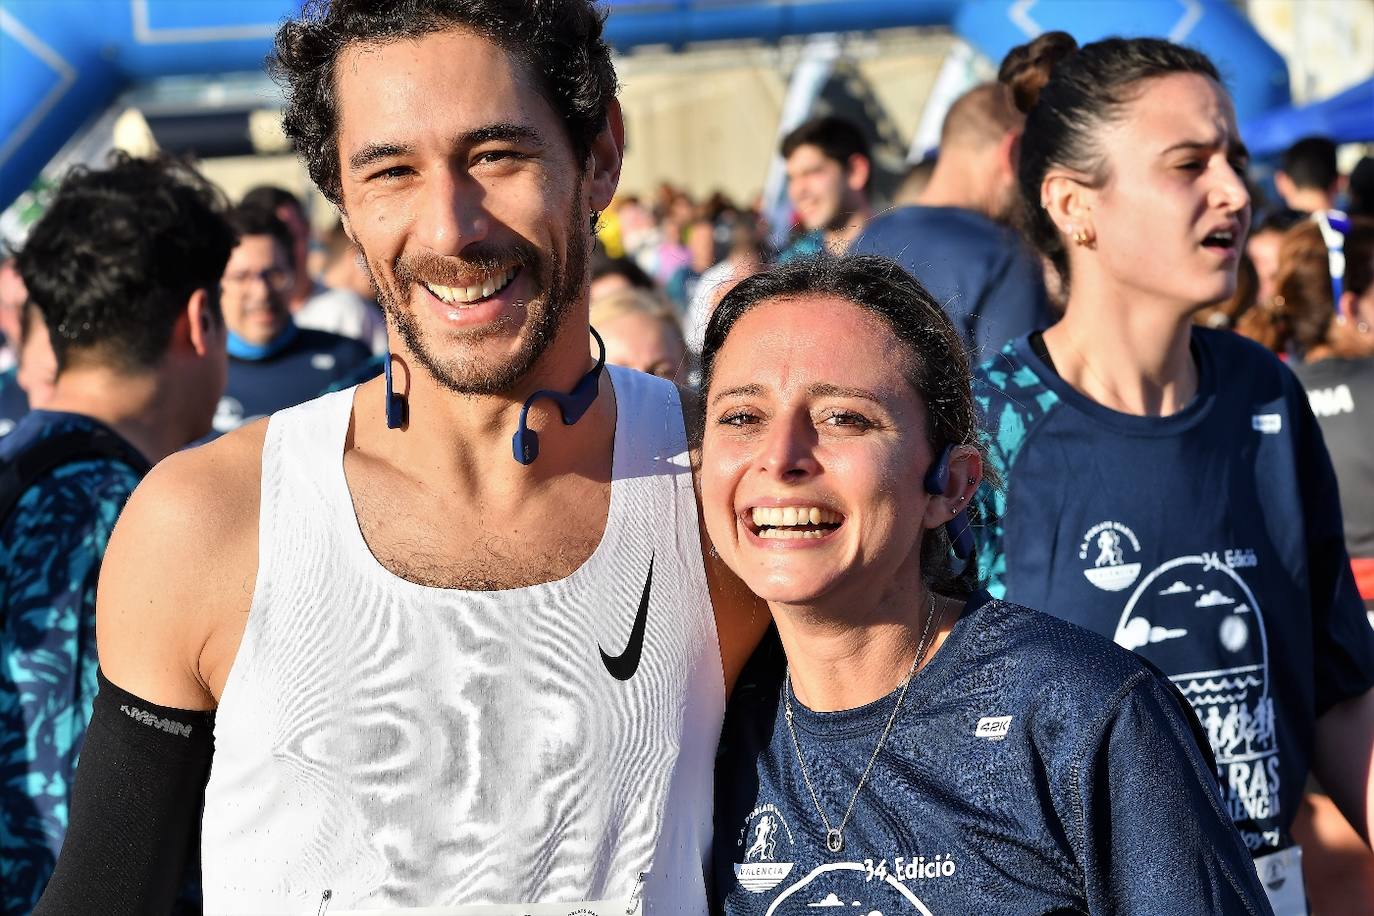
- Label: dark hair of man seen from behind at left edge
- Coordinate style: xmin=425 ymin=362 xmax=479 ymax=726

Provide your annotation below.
xmin=15 ymin=152 xmax=238 ymax=372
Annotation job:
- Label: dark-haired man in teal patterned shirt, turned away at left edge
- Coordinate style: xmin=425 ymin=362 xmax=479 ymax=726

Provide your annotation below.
xmin=0 ymin=157 xmax=234 ymax=916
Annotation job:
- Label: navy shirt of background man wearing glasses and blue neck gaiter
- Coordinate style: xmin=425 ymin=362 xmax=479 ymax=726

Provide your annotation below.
xmin=214 ymin=325 xmax=372 ymax=434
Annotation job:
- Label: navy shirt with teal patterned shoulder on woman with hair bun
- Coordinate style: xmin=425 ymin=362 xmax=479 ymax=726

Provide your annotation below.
xmin=974 ymin=328 xmax=1374 ymax=856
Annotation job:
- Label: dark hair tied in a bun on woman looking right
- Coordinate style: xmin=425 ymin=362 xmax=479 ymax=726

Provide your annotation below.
xmin=998 ymin=32 xmax=1221 ymax=282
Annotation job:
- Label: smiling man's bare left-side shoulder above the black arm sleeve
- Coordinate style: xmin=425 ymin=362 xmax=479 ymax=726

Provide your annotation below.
xmin=96 ymin=420 xmax=267 ymax=709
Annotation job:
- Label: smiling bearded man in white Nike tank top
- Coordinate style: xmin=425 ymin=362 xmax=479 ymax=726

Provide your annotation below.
xmin=38 ymin=0 xmax=765 ymax=916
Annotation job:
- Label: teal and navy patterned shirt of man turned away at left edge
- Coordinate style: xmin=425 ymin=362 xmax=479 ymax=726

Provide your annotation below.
xmin=0 ymin=460 xmax=139 ymax=912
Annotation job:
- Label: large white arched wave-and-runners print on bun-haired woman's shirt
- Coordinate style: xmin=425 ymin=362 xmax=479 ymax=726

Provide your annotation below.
xmin=1114 ymin=549 xmax=1282 ymax=850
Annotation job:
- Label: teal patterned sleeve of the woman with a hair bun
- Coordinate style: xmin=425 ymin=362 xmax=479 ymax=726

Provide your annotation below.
xmin=973 ymin=342 xmax=1059 ymax=597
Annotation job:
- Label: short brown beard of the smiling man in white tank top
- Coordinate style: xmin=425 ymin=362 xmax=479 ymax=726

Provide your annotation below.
xmin=359 ymin=186 xmax=591 ymax=396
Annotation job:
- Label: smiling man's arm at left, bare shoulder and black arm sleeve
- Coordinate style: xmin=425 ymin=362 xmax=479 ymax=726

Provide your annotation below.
xmin=36 ymin=423 xmax=265 ymax=916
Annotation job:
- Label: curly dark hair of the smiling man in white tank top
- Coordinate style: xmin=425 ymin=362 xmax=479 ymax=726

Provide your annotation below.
xmin=268 ymin=0 xmax=617 ymax=206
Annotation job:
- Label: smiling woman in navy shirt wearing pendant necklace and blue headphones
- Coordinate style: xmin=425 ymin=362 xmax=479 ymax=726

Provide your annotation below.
xmin=702 ymin=257 xmax=1268 ymax=916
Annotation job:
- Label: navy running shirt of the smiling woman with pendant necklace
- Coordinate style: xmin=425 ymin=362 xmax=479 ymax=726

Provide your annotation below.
xmin=713 ymin=595 xmax=1270 ymax=916
